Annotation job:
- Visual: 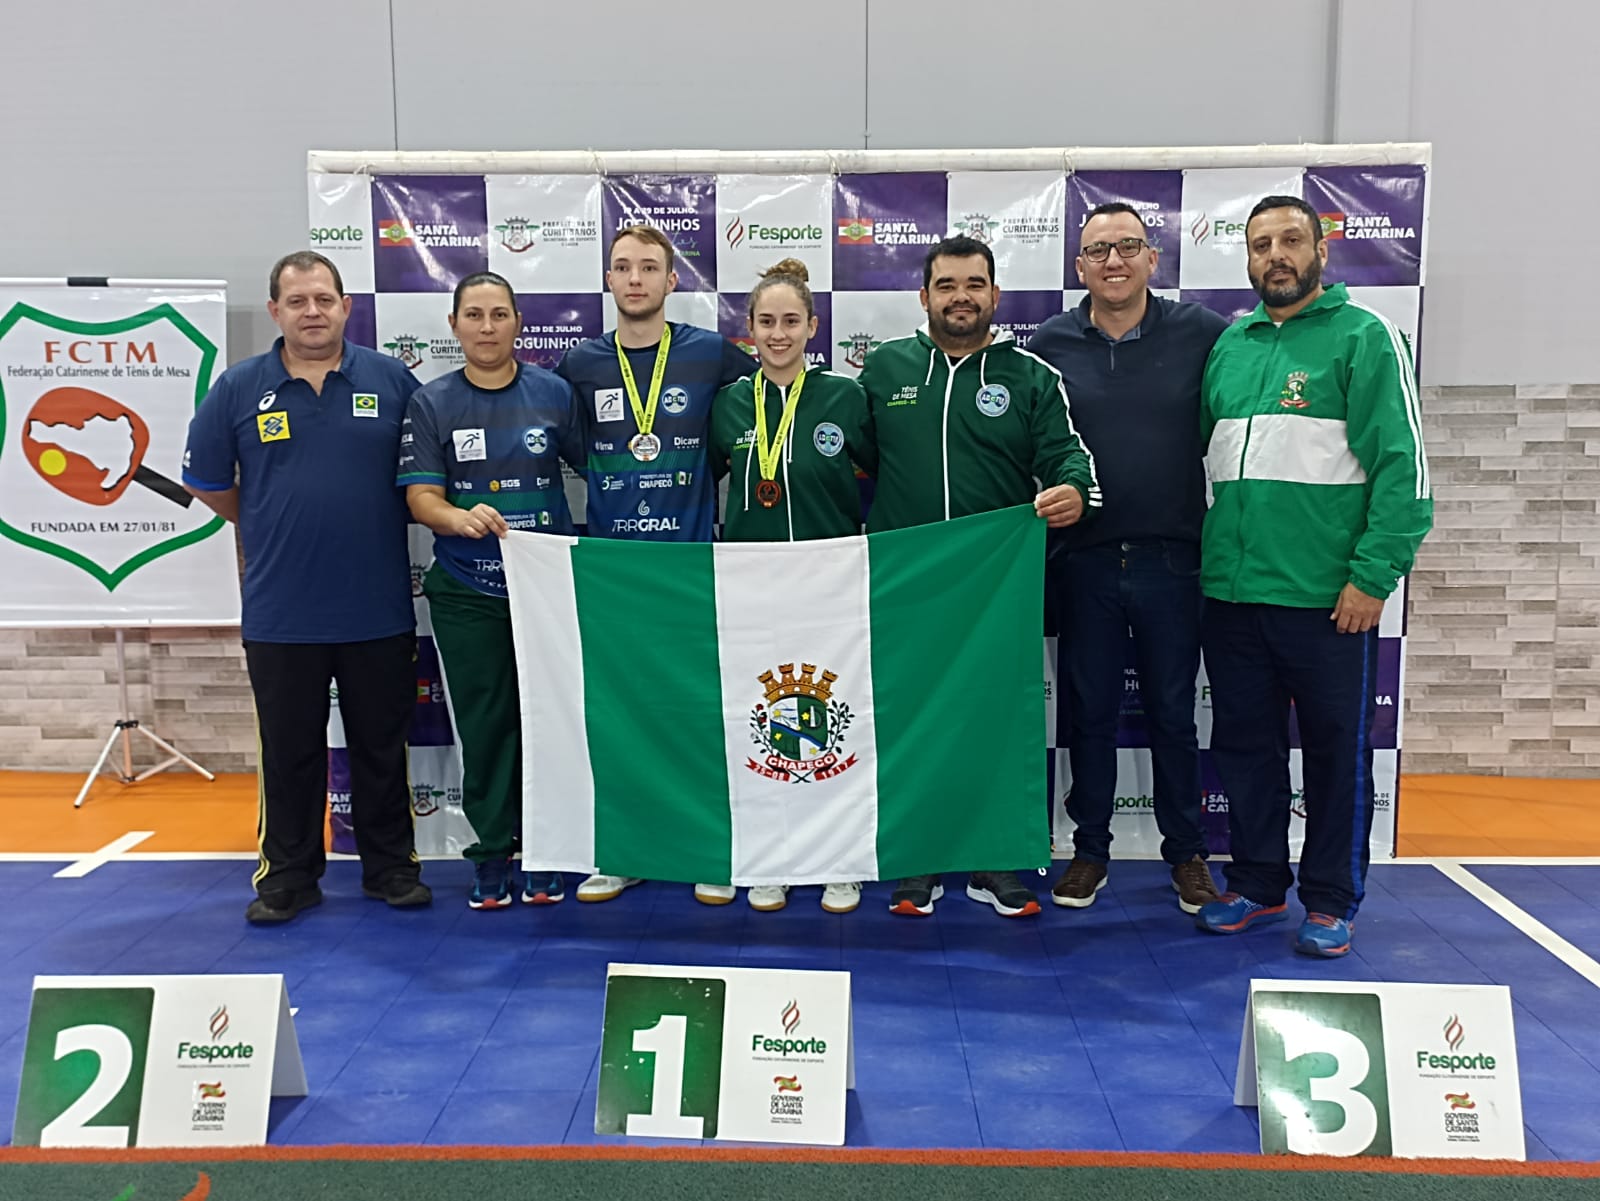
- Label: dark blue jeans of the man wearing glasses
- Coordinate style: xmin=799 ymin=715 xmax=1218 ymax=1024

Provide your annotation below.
xmin=1051 ymin=539 xmax=1205 ymax=864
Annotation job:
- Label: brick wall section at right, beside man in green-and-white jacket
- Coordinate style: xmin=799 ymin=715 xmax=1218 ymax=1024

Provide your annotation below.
xmin=1402 ymin=384 xmax=1600 ymax=776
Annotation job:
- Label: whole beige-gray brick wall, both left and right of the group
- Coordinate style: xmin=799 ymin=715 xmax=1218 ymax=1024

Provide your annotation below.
xmin=0 ymin=385 xmax=1600 ymax=776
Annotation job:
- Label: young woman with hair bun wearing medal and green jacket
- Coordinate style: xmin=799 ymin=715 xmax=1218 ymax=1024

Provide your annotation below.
xmin=710 ymin=259 xmax=877 ymax=913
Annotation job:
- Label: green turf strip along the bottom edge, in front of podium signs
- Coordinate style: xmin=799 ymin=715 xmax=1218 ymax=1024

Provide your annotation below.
xmin=0 ymin=1159 xmax=1600 ymax=1201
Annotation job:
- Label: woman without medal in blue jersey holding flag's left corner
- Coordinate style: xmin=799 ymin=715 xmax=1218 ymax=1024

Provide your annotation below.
xmin=397 ymin=272 xmax=584 ymax=910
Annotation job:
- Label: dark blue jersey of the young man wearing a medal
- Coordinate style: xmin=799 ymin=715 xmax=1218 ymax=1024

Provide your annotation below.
xmin=555 ymin=321 xmax=755 ymax=542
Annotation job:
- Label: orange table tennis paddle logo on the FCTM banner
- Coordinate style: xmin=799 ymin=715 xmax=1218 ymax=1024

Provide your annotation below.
xmin=22 ymin=387 xmax=194 ymax=509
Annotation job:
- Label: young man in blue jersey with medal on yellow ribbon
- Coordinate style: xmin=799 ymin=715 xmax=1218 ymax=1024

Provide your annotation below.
xmin=555 ymin=225 xmax=755 ymax=904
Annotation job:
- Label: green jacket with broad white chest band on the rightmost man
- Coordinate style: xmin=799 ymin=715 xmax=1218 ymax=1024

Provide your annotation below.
xmin=1200 ymin=283 xmax=1434 ymax=609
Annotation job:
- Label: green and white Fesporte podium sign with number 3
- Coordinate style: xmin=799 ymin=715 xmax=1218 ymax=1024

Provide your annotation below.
xmin=1234 ymin=980 xmax=1526 ymax=1159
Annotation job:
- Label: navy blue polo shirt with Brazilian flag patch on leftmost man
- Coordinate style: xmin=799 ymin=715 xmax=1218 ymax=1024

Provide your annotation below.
xmin=184 ymin=337 xmax=416 ymax=643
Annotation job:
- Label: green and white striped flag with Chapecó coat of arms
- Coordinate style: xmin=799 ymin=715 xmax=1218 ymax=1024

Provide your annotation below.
xmin=501 ymin=507 xmax=1050 ymax=884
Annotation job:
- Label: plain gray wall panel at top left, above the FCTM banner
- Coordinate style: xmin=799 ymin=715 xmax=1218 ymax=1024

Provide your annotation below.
xmin=0 ymin=0 xmax=394 ymax=358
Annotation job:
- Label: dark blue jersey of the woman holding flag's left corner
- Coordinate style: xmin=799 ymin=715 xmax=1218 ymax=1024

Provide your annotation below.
xmin=395 ymin=363 xmax=584 ymax=598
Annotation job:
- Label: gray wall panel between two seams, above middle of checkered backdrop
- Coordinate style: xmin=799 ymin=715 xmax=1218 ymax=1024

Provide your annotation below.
xmin=394 ymin=0 xmax=866 ymax=150
